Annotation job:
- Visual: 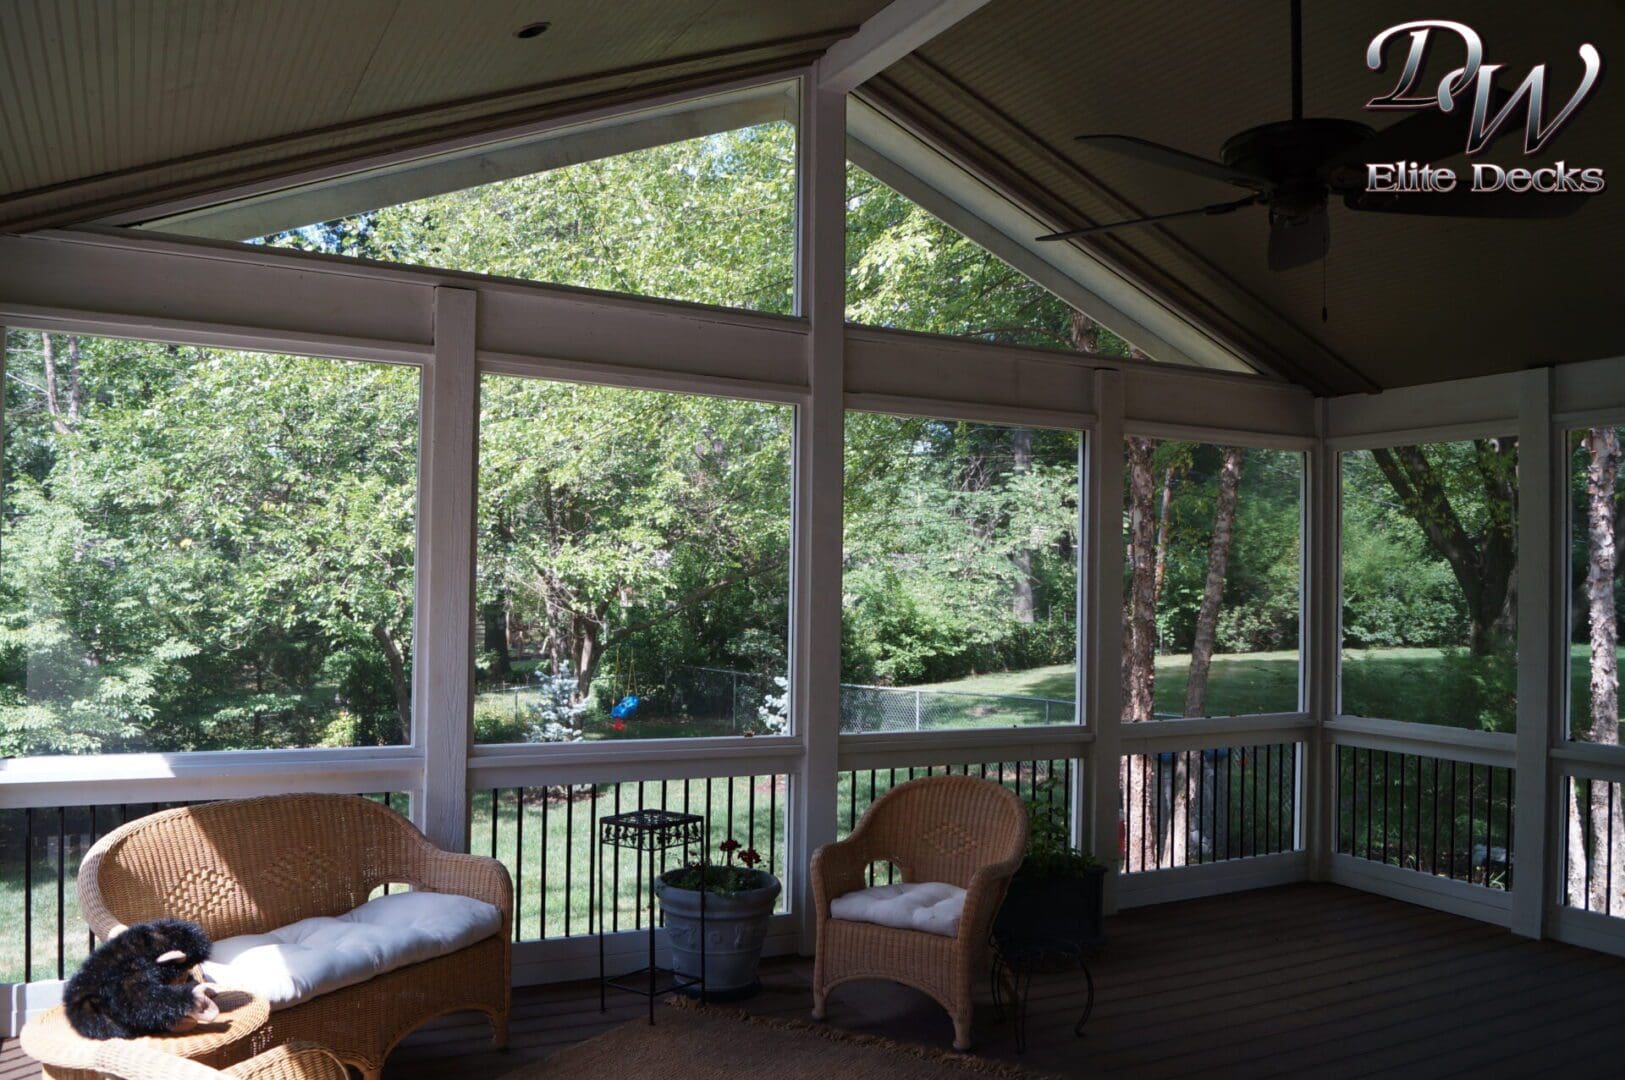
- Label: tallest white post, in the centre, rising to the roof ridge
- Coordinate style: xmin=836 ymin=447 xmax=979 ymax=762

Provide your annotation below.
xmin=788 ymin=77 xmax=847 ymax=953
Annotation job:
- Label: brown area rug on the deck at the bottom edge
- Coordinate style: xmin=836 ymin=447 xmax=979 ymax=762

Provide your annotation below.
xmin=504 ymin=1000 xmax=1045 ymax=1080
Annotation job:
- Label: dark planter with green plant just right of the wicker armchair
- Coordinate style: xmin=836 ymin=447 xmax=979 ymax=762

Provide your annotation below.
xmin=993 ymin=802 xmax=1108 ymax=950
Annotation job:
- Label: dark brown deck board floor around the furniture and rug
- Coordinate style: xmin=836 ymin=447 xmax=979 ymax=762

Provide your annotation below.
xmin=0 ymin=885 xmax=1625 ymax=1080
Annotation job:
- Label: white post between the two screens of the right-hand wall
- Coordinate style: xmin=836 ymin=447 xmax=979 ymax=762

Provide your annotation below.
xmin=1511 ymin=369 xmax=1568 ymax=937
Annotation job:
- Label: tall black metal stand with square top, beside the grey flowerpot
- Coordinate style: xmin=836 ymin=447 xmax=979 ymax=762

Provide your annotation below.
xmin=588 ymin=810 xmax=705 ymax=1023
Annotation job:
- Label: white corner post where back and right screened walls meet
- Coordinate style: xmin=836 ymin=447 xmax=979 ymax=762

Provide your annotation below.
xmin=1297 ymin=400 xmax=1342 ymax=882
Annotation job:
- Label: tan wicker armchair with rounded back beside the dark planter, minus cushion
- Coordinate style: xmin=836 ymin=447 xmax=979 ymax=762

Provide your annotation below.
xmin=813 ymin=776 xmax=1027 ymax=1051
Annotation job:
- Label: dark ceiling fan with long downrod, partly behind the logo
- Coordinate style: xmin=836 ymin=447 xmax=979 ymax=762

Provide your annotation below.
xmin=1038 ymin=0 xmax=1586 ymax=270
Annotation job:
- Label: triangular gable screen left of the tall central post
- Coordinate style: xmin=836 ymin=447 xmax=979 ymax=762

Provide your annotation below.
xmin=145 ymin=84 xmax=796 ymax=313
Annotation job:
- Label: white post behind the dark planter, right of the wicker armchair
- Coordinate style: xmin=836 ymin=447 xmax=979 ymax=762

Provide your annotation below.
xmin=1082 ymin=370 xmax=1123 ymax=913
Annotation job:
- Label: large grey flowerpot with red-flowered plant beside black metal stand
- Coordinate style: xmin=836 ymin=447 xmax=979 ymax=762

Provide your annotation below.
xmin=655 ymin=840 xmax=783 ymax=999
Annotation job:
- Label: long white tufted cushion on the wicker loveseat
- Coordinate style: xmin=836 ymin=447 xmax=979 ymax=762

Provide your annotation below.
xmin=203 ymin=892 xmax=502 ymax=1010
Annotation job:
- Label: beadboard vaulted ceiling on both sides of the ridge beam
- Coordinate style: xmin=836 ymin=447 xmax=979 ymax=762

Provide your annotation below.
xmin=0 ymin=0 xmax=1625 ymax=393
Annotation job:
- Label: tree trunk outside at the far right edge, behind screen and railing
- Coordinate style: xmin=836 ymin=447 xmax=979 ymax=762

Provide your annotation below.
xmin=1573 ymin=427 xmax=1625 ymax=911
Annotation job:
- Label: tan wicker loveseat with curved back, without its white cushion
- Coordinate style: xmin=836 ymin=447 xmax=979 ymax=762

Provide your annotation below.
xmin=78 ymin=794 xmax=514 ymax=1080
